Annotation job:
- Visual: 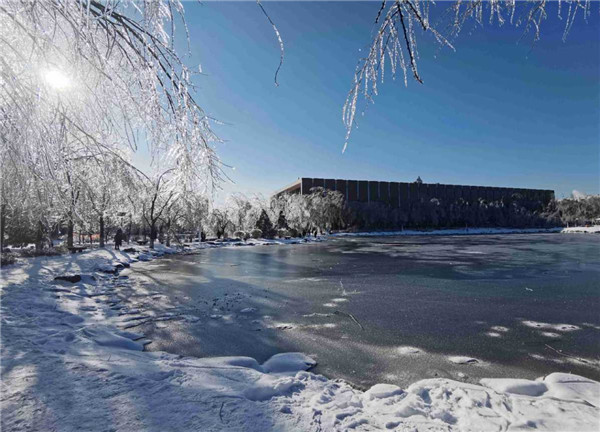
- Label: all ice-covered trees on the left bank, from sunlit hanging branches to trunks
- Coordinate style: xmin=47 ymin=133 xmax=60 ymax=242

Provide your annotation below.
xmin=0 ymin=0 xmax=221 ymax=248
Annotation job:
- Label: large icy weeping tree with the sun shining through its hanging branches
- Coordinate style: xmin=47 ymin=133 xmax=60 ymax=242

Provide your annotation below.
xmin=0 ymin=0 xmax=221 ymax=248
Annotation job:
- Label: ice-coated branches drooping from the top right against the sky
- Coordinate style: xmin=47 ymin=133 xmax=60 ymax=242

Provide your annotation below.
xmin=342 ymin=0 xmax=591 ymax=151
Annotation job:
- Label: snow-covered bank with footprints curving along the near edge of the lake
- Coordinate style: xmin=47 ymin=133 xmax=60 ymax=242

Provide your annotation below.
xmin=1 ymin=245 xmax=600 ymax=432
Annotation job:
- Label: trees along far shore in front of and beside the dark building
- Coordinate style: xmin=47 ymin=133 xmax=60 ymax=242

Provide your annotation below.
xmin=193 ymin=187 xmax=600 ymax=237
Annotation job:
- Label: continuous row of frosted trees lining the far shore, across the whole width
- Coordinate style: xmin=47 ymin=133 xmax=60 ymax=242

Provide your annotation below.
xmin=2 ymin=180 xmax=600 ymax=247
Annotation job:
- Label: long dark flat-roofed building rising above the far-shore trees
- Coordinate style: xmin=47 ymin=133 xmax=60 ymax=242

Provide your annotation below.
xmin=275 ymin=177 xmax=554 ymax=208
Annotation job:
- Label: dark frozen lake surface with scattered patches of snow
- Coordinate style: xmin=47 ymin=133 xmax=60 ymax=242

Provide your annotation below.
xmin=122 ymin=234 xmax=600 ymax=387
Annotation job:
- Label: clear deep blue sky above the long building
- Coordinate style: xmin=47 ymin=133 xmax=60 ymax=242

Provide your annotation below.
xmin=179 ymin=2 xmax=600 ymax=199
